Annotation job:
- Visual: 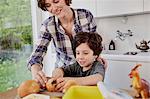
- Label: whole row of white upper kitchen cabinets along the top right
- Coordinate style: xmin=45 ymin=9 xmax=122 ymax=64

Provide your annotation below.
xmin=38 ymin=0 xmax=150 ymax=19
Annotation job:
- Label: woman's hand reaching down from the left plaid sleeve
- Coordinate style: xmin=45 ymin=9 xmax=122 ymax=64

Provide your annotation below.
xmin=31 ymin=65 xmax=47 ymax=87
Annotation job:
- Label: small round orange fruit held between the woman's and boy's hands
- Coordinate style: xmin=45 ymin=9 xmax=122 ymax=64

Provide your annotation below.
xmin=46 ymin=78 xmax=56 ymax=92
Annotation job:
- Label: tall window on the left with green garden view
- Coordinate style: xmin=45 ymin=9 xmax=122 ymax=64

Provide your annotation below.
xmin=0 ymin=0 xmax=33 ymax=92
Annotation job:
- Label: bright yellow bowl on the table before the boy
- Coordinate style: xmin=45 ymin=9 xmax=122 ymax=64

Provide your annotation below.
xmin=63 ymin=86 xmax=104 ymax=99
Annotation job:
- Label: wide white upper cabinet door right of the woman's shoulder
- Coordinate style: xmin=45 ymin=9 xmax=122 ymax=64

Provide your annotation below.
xmin=97 ymin=0 xmax=143 ymax=17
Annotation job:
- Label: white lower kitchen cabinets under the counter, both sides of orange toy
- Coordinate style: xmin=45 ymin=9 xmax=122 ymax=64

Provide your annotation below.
xmin=104 ymin=60 xmax=150 ymax=89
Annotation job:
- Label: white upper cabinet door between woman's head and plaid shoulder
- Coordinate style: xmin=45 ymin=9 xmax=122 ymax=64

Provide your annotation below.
xmin=71 ymin=0 xmax=96 ymax=17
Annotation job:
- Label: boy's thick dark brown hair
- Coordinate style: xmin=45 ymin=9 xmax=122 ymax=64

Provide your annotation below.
xmin=73 ymin=32 xmax=102 ymax=55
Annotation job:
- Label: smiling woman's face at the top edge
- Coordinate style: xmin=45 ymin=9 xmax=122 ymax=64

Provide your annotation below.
xmin=45 ymin=0 xmax=70 ymax=18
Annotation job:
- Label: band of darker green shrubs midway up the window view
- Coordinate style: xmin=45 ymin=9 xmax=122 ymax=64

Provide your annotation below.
xmin=0 ymin=25 xmax=32 ymax=50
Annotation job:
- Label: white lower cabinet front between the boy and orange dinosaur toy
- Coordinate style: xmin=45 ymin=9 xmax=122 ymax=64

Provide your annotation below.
xmin=104 ymin=60 xmax=136 ymax=89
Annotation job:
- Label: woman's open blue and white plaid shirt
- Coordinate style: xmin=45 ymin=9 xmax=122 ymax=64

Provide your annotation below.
xmin=28 ymin=9 xmax=96 ymax=69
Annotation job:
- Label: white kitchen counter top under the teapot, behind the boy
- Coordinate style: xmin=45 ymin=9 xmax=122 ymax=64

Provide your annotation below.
xmin=101 ymin=51 xmax=150 ymax=62
